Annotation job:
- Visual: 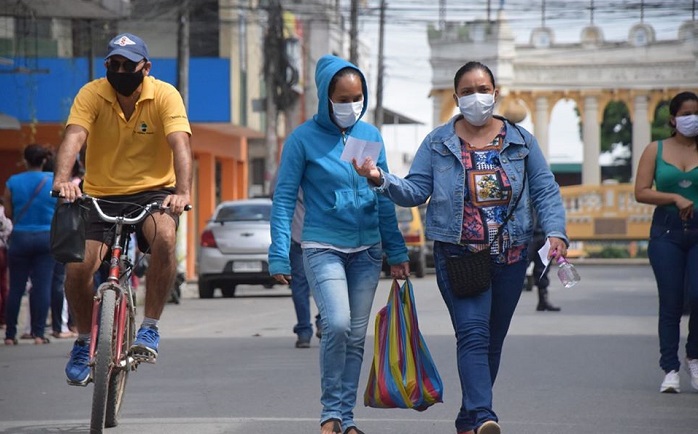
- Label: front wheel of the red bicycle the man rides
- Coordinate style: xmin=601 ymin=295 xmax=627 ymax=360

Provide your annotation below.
xmin=90 ymin=289 xmax=116 ymax=433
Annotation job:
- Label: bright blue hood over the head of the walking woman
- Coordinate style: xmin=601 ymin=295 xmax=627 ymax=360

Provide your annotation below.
xmin=314 ymin=54 xmax=368 ymax=129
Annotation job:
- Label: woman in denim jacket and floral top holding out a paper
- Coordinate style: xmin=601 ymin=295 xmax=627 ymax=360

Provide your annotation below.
xmin=354 ymin=62 xmax=569 ymax=434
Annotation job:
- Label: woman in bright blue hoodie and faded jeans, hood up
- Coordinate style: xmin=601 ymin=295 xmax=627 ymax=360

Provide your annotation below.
xmin=269 ymin=55 xmax=409 ymax=434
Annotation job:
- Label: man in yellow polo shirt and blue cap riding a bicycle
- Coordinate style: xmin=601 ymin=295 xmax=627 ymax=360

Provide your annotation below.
xmin=53 ymin=33 xmax=192 ymax=386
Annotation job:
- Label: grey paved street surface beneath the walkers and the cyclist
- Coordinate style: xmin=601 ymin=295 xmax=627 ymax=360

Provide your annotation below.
xmin=0 ymin=264 xmax=698 ymax=434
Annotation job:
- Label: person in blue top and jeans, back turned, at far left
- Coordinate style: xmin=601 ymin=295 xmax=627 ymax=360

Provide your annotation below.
xmin=3 ymin=144 xmax=56 ymax=345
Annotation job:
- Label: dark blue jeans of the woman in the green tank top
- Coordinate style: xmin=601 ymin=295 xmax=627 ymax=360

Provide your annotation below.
xmin=647 ymin=207 xmax=698 ymax=372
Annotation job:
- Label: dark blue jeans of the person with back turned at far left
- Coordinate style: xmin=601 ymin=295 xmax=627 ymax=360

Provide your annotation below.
xmin=5 ymin=231 xmax=56 ymax=339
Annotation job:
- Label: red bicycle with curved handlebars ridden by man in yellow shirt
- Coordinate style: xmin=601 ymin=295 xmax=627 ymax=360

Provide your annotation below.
xmin=51 ymin=191 xmax=191 ymax=433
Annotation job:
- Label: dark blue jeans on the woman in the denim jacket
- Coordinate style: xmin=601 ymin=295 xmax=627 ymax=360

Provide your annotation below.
xmin=434 ymin=241 xmax=527 ymax=432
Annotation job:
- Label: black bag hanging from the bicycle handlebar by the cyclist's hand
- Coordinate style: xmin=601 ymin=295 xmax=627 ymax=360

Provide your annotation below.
xmin=51 ymin=201 xmax=88 ymax=264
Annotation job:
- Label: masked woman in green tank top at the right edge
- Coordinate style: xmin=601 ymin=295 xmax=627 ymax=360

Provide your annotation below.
xmin=635 ymin=92 xmax=698 ymax=393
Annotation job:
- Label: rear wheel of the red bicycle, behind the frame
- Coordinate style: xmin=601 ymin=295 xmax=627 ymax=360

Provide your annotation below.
xmin=104 ymin=293 xmax=136 ymax=428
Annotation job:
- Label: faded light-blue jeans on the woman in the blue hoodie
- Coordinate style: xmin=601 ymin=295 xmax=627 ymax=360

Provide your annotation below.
xmin=303 ymin=244 xmax=380 ymax=430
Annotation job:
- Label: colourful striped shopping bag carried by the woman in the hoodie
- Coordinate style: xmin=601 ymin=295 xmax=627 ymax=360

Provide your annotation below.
xmin=364 ymin=279 xmax=443 ymax=411
